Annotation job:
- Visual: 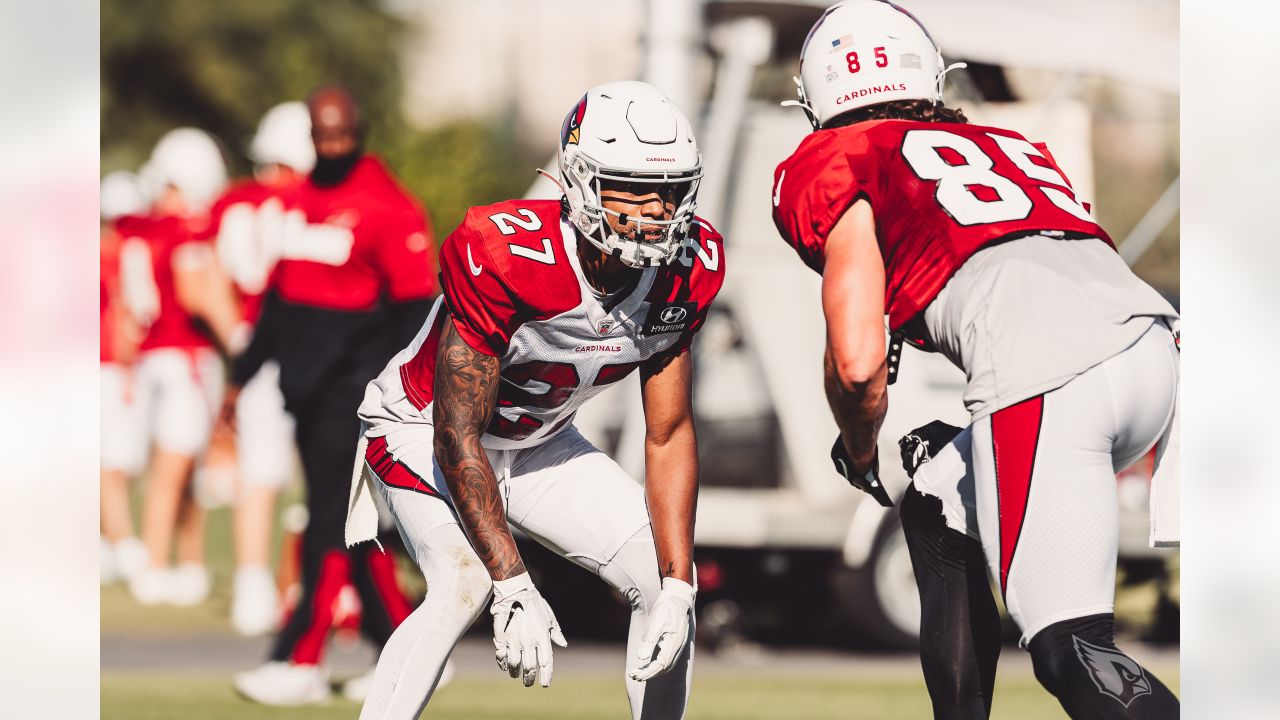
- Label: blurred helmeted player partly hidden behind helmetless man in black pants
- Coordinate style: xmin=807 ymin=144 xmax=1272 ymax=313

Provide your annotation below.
xmin=210 ymin=101 xmax=315 ymax=635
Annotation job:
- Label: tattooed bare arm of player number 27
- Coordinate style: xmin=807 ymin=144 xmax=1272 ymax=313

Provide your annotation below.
xmin=431 ymin=319 xmax=525 ymax=580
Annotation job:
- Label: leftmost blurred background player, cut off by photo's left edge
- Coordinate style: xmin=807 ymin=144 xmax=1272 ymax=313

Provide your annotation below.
xmin=99 ymin=170 xmax=147 ymax=584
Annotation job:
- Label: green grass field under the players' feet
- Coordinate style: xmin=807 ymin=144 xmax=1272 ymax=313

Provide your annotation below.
xmin=101 ymin=484 xmax=1179 ymax=720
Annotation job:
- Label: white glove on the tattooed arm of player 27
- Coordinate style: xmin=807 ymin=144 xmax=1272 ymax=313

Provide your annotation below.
xmin=489 ymin=573 xmax=568 ymax=688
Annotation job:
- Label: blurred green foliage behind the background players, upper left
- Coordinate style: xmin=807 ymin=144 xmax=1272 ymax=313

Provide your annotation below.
xmin=101 ymin=0 xmax=541 ymax=238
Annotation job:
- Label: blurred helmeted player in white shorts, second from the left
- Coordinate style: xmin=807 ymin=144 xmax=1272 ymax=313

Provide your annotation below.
xmin=123 ymin=128 xmax=239 ymax=606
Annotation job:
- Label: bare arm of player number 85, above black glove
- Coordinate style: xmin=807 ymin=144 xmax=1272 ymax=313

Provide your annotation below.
xmin=822 ymin=200 xmax=888 ymax=473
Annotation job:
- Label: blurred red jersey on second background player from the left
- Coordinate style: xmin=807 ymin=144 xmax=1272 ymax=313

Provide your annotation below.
xmin=120 ymin=215 xmax=214 ymax=351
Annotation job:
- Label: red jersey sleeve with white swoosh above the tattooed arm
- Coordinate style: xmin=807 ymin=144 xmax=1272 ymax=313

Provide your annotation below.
xmin=440 ymin=217 xmax=520 ymax=357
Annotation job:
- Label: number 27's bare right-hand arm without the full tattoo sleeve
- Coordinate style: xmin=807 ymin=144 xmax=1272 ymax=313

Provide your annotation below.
xmin=640 ymin=352 xmax=698 ymax=584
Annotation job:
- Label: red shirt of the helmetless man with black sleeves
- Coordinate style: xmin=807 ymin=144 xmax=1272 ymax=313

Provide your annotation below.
xmin=273 ymin=155 xmax=436 ymax=311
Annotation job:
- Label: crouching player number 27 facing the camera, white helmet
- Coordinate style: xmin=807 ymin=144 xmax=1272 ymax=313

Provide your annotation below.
xmin=347 ymin=82 xmax=724 ymax=720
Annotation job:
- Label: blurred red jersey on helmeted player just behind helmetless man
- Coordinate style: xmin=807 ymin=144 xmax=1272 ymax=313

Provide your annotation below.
xmin=209 ymin=179 xmax=298 ymax=323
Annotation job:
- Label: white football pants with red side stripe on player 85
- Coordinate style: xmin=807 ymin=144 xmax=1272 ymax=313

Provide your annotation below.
xmin=914 ymin=323 xmax=1179 ymax=647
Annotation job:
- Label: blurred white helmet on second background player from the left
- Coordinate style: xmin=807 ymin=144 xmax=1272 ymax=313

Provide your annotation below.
xmin=141 ymin=128 xmax=227 ymax=214
